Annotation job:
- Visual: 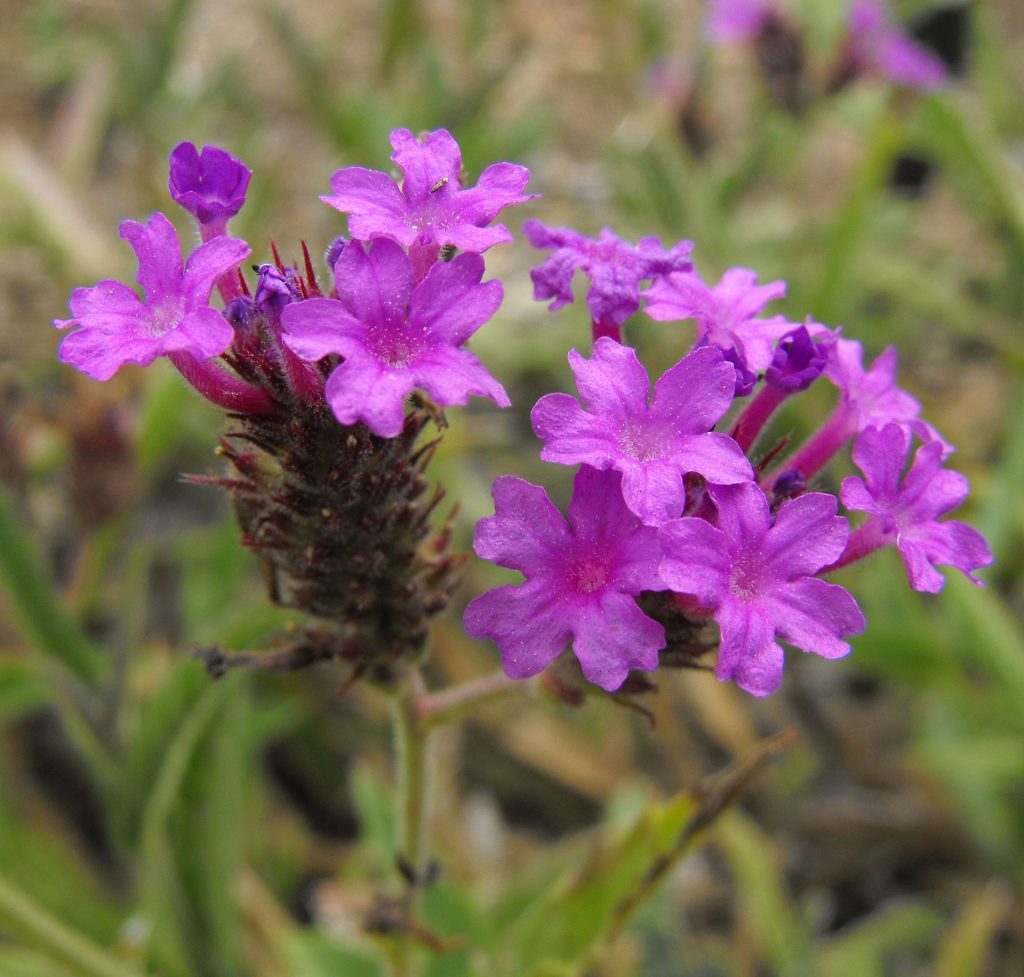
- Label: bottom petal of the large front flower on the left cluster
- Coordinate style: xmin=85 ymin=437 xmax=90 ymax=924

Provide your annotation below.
xmin=324 ymin=351 xmax=415 ymax=437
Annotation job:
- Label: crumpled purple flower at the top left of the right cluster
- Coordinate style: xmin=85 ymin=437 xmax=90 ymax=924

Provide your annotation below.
xmin=522 ymin=220 xmax=693 ymax=339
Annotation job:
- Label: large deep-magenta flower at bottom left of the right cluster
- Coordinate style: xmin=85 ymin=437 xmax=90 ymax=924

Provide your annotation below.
xmin=465 ymin=467 xmax=665 ymax=692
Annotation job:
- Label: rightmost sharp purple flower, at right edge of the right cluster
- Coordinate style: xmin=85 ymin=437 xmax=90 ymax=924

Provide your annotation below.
xmin=840 ymin=424 xmax=992 ymax=594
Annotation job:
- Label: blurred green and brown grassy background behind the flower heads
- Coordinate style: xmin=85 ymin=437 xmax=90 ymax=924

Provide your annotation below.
xmin=0 ymin=0 xmax=1024 ymax=977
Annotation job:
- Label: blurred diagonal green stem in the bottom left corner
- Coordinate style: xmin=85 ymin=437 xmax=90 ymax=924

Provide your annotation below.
xmin=0 ymin=878 xmax=151 ymax=977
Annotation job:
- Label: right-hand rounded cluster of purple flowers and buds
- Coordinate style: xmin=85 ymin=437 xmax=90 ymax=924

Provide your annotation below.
xmin=465 ymin=222 xmax=991 ymax=695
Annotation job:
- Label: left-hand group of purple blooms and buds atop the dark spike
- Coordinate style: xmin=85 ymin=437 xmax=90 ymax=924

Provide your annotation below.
xmin=55 ymin=129 xmax=532 ymax=437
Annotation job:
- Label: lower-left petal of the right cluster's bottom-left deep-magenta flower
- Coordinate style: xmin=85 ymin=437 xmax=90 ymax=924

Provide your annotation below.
xmin=463 ymin=581 xmax=571 ymax=679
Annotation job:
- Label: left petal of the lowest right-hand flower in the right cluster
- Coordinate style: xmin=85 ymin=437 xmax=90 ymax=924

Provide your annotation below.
xmin=658 ymin=517 xmax=732 ymax=607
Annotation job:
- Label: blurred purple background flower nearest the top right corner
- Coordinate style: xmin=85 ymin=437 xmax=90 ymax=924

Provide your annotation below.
xmin=844 ymin=0 xmax=946 ymax=91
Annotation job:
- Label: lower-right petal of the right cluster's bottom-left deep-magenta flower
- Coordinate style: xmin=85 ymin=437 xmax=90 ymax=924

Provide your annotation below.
xmin=572 ymin=593 xmax=665 ymax=692
